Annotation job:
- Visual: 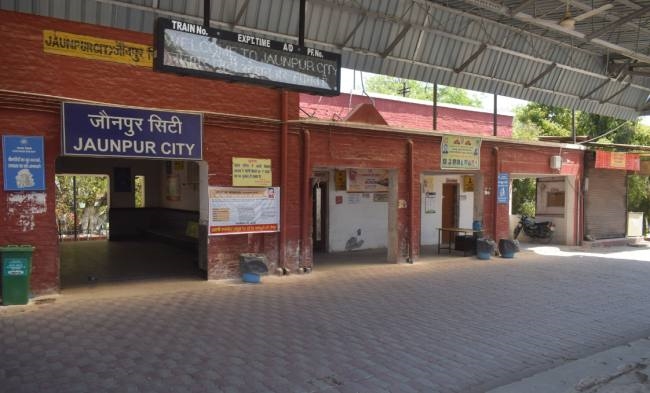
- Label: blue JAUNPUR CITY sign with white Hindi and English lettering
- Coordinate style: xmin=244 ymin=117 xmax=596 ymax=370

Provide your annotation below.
xmin=61 ymin=102 xmax=203 ymax=160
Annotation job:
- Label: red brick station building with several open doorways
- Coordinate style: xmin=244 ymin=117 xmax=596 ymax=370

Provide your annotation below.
xmin=0 ymin=11 xmax=583 ymax=293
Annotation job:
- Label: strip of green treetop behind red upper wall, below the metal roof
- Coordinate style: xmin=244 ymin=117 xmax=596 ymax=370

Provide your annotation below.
xmin=364 ymin=75 xmax=481 ymax=108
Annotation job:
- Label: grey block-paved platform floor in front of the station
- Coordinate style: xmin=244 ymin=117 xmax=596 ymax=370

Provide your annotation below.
xmin=0 ymin=249 xmax=650 ymax=393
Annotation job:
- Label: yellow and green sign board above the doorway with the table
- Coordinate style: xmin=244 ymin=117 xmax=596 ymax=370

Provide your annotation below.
xmin=440 ymin=135 xmax=481 ymax=169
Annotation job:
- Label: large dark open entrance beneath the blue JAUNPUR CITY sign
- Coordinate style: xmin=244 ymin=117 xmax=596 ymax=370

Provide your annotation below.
xmin=55 ymin=157 xmax=207 ymax=289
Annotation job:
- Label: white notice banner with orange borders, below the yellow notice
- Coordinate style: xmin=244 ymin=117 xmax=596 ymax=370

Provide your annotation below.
xmin=208 ymin=187 xmax=280 ymax=235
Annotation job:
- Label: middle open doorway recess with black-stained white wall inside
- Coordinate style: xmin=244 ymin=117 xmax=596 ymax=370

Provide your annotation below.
xmin=312 ymin=168 xmax=397 ymax=268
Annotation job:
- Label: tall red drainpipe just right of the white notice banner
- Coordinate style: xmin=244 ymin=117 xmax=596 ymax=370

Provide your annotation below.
xmin=278 ymin=90 xmax=289 ymax=268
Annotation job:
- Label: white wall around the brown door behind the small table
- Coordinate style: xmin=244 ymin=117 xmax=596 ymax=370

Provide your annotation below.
xmin=420 ymin=174 xmax=477 ymax=245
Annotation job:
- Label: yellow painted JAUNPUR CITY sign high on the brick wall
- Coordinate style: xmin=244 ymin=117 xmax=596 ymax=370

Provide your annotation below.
xmin=43 ymin=30 xmax=153 ymax=68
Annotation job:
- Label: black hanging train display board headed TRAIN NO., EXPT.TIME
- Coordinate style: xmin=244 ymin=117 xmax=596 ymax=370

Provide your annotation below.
xmin=154 ymin=18 xmax=341 ymax=95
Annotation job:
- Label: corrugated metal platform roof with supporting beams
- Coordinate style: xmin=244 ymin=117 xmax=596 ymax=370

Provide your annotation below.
xmin=0 ymin=0 xmax=650 ymax=119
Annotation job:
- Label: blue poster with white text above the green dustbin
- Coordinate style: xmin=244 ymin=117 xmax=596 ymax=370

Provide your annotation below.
xmin=2 ymin=135 xmax=45 ymax=191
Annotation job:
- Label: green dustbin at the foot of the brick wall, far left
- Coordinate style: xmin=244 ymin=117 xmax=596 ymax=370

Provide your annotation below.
xmin=0 ymin=246 xmax=34 ymax=306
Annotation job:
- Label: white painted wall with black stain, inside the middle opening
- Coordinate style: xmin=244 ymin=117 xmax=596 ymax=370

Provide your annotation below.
xmin=328 ymin=172 xmax=388 ymax=252
